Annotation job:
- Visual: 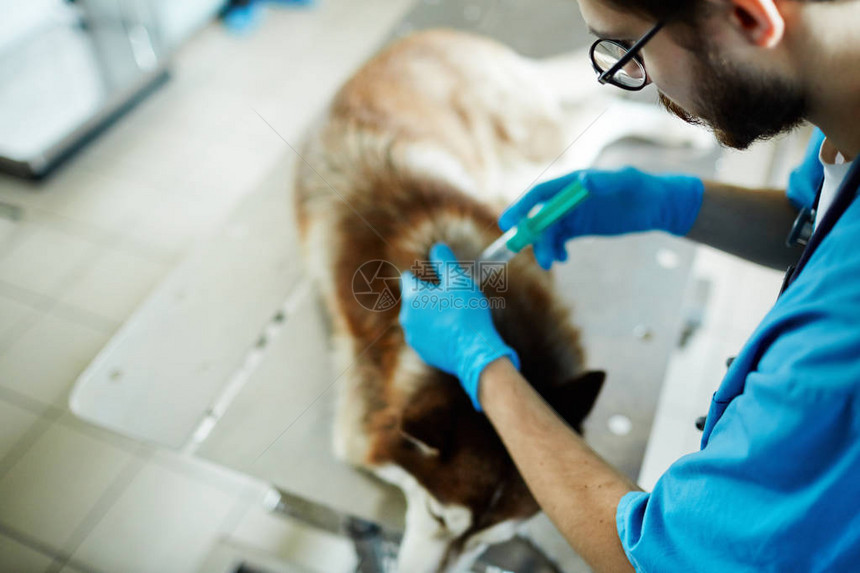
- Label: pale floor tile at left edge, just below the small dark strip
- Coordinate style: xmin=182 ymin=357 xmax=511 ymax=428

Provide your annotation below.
xmin=0 ymin=222 xmax=95 ymax=296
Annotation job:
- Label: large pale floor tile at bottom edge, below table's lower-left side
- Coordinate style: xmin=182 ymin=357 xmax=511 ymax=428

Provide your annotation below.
xmin=73 ymin=463 xmax=235 ymax=573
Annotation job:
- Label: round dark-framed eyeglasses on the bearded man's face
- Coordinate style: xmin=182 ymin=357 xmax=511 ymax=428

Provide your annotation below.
xmin=589 ymin=22 xmax=664 ymax=92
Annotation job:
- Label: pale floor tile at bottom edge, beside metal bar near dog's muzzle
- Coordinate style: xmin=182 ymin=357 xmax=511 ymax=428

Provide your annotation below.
xmin=231 ymin=506 xmax=358 ymax=573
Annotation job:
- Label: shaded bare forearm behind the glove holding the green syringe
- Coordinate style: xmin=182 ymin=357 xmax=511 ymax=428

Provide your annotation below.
xmin=687 ymin=181 xmax=800 ymax=270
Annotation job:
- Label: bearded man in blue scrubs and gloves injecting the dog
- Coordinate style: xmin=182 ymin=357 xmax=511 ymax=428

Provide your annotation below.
xmin=400 ymin=0 xmax=860 ymax=573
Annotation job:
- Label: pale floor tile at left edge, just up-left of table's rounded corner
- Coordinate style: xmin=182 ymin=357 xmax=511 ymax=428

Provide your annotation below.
xmin=0 ymin=313 xmax=107 ymax=407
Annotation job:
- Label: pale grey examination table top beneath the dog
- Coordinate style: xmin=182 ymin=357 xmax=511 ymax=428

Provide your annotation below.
xmin=72 ymin=0 xmax=718 ymax=571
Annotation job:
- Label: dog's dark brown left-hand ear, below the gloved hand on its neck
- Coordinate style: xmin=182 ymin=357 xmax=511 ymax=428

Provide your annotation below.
xmin=400 ymin=383 xmax=457 ymax=457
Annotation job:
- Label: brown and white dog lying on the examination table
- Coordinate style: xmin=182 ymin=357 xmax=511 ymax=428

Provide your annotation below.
xmin=295 ymin=30 xmax=712 ymax=573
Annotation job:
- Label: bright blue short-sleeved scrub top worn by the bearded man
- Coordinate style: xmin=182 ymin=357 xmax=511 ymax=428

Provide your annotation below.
xmin=616 ymin=132 xmax=860 ymax=573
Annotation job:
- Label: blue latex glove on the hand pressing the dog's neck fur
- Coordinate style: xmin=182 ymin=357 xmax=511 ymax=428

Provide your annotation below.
xmin=400 ymin=243 xmax=520 ymax=412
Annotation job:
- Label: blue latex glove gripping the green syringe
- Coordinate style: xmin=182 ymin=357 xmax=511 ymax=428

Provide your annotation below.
xmin=499 ymin=167 xmax=705 ymax=269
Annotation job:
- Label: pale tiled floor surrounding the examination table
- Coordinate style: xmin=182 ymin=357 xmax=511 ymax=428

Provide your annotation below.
xmin=0 ymin=0 xmax=804 ymax=573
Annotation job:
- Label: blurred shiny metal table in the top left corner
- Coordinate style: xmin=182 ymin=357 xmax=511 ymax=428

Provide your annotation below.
xmin=0 ymin=0 xmax=221 ymax=178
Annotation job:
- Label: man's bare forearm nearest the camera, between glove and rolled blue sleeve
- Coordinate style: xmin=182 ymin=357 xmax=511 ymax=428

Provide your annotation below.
xmin=479 ymin=358 xmax=639 ymax=572
